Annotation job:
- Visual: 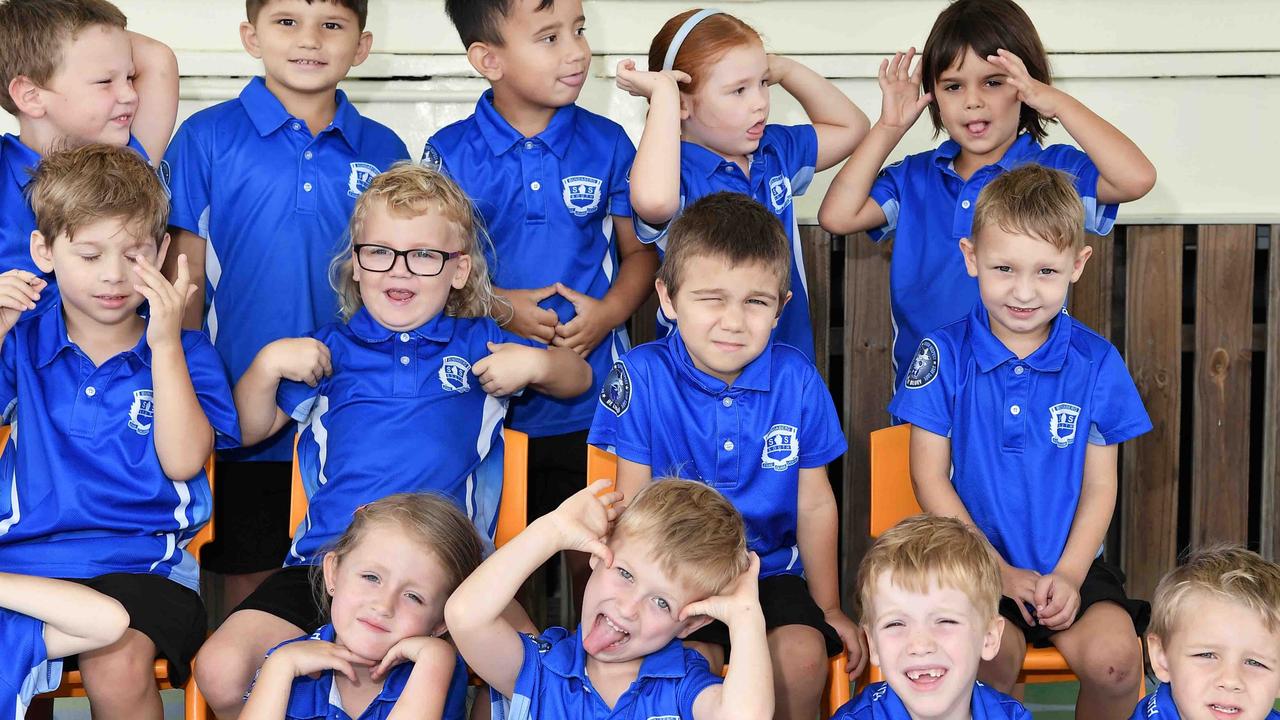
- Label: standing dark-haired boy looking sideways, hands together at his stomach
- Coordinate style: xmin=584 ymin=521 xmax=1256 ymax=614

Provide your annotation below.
xmin=422 ymin=0 xmax=658 ymax=597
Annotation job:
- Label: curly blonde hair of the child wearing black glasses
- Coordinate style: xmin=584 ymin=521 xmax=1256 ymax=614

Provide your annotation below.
xmin=329 ymin=161 xmax=502 ymax=320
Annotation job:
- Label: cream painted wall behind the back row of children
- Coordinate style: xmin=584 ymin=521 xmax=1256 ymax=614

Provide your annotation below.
xmin=0 ymin=0 xmax=1280 ymax=223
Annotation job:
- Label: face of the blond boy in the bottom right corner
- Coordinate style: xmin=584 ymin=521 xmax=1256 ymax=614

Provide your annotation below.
xmin=1148 ymin=593 xmax=1280 ymax=720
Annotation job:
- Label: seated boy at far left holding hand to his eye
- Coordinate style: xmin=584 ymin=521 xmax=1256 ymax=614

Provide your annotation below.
xmin=0 ymin=145 xmax=239 ymax=719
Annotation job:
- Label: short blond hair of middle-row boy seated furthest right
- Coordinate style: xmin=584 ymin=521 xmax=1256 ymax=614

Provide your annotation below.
xmin=972 ymin=163 xmax=1084 ymax=252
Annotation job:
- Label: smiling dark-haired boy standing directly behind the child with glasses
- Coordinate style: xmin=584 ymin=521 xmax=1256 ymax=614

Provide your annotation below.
xmin=161 ymin=0 xmax=408 ymax=655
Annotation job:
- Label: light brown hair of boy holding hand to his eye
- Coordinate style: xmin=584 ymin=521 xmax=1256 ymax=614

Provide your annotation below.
xmin=28 ymin=143 xmax=169 ymax=245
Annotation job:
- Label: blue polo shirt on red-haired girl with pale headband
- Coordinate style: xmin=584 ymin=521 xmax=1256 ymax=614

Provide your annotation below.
xmin=635 ymin=126 xmax=818 ymax=361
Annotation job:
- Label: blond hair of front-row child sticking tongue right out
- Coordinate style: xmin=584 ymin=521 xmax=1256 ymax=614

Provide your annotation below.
xmin=612 ymin=478 xmax=749 ymax=598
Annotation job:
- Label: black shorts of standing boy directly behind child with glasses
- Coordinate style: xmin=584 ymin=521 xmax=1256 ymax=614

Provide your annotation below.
xmin=200 ymin=460 xmax=293 ymax=575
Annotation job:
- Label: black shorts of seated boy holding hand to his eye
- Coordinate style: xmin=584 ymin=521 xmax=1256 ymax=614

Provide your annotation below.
xmin=63 ymin=573 xmax=209 ymax=688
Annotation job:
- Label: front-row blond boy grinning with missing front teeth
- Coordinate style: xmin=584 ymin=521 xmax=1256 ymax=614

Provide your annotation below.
xmin=832 ymin=515 xmax=1032 ymax=720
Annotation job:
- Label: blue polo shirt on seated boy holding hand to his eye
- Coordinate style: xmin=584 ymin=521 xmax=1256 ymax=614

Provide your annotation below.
xmin=0 ymin=301 xmax=239 ymax=592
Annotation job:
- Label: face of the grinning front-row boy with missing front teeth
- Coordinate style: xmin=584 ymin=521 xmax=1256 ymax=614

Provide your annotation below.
xmin=863 ymin=573 xmax=1005 ymax=720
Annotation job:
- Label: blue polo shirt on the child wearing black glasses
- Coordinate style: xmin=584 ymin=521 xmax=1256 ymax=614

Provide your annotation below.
xmin=276 ymin=307 xmax=536 ymax=565
